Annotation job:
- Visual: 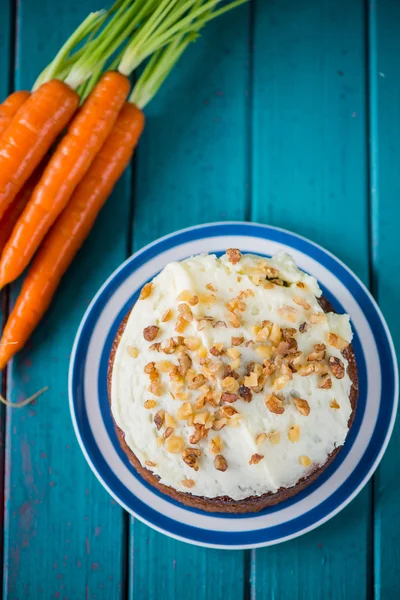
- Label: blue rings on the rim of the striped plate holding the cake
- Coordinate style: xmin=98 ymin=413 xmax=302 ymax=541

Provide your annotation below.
xmin=69 ymin=222 xmax=398 ymax=549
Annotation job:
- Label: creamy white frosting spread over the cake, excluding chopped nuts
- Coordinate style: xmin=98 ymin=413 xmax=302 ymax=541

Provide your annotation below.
xmin=111 ymin=253 xmax=352 ymax=500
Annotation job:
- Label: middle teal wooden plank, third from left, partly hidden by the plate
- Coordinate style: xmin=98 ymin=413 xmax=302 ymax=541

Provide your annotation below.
xmin=130 ymin=6 xmax=249 ymax=600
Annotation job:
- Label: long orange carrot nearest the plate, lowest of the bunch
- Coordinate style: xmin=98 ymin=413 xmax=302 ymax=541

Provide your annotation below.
xmin=0 ymin=103 xmax=144 ymax=369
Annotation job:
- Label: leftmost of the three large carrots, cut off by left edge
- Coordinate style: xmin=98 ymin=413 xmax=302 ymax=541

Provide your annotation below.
xmin=0 ymin=79 xmax=79 ymax=218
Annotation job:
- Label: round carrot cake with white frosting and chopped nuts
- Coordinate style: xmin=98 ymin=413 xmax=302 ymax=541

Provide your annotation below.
xmin=108 ymin=249 xmax=358 ymax=513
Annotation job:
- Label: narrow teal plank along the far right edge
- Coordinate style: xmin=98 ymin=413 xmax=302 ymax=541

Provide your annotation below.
xmin=368 ymin=0 xmax=400 ymax=600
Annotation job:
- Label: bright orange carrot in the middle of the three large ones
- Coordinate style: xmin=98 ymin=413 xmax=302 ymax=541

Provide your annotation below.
xmin=0 ymin=71 xmax=130 ymax=287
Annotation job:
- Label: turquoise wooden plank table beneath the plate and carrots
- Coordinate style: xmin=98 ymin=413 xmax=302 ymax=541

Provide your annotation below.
xmin=0 ymin=0 xmax=400 ymax=600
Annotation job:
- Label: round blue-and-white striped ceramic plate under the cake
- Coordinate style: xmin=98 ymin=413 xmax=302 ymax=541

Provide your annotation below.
xmin=69 ymin=223 xmax=398 ymax=548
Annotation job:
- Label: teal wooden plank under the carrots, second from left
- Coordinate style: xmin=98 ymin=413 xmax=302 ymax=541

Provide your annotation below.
xmin=4 ymin=0 xmax=130 ymax=600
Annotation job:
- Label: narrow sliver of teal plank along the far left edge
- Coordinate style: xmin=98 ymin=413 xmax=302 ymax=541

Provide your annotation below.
xmin=0 ymin=0 xmax=13 ymax=589
